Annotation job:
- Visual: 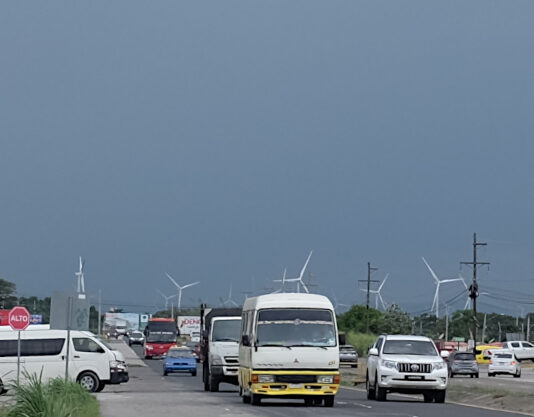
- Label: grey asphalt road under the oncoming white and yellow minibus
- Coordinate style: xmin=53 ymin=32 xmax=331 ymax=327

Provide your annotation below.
xmin=98 ymin=347 xmax=532 ymax=417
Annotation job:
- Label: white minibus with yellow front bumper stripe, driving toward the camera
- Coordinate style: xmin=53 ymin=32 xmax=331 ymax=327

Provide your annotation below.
xmin=239 ymin=293 xmax=340 ymax=407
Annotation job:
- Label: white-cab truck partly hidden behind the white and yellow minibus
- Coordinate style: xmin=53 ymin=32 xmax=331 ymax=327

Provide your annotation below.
xmin=200 ymin=305 xmax=241 ymax=392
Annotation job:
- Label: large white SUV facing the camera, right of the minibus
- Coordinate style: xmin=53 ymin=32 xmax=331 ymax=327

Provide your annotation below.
xmin=366 ymin=335 xmax=449 ymax=403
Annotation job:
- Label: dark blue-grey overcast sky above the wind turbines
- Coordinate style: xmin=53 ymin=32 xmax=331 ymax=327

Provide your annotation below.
xmin=0 ymin=0 xmax=534 ymax=315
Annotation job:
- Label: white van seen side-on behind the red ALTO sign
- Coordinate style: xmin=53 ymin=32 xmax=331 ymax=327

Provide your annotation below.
xmin=0 ymin=329 xmax=129 ymax=392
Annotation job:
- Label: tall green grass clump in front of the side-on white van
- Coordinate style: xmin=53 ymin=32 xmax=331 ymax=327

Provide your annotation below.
xmin=0 ymin=374 xmax=99 ymax=417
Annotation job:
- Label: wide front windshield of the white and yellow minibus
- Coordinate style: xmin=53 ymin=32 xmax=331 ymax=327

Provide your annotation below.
xmin=257 ymin=309 xmax=337 ymax=348
